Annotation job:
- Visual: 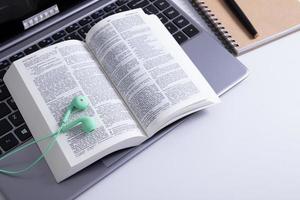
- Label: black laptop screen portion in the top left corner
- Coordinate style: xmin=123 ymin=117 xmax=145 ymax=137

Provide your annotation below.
xmin=0 ymin=0 xmax=84 ymax=44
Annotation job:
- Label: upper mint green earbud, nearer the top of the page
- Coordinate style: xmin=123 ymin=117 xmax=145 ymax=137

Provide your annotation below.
xmin=62 ymin=96 xmax=89 ymax=123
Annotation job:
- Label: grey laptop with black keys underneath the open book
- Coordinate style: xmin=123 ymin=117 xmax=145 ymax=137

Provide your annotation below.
xmin=0 ymin=0 xmax=247 ymax=200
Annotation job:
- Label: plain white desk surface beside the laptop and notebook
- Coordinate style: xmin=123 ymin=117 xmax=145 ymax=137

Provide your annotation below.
xmin=78 ymin=1 xmax=300 ymax=200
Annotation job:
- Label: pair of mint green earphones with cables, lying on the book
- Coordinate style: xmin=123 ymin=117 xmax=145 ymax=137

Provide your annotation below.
xmin=0 ymin=96 xmax=97 ymax=175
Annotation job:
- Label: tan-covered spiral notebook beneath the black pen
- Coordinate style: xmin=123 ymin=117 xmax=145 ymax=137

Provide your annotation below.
xmin=192 ymin=0 xmax=300 ymax=55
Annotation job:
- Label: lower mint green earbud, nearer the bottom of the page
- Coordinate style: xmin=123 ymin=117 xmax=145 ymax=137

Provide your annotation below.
xmin=61 ymin=116 xmax=97 ymax=133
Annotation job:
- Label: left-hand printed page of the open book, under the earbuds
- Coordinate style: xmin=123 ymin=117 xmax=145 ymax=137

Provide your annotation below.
xmin=15 ymin=40 xmax=145 ymax=164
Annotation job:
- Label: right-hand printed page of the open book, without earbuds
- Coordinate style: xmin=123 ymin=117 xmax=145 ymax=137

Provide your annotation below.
xmin=86 ymin=9 xmax=218 ymax=136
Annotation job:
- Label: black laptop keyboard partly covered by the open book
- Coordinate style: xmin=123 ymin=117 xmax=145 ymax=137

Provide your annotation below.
xmin=0 ymin=0 xmax=199 ymax=155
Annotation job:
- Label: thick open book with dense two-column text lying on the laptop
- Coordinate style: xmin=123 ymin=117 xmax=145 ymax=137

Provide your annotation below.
xmin=4 ymin=9 xmax=219 ymax=182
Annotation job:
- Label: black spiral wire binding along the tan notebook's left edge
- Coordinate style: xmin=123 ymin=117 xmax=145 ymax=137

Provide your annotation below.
xmin=191 ymin=0 xmax=239 ymax=54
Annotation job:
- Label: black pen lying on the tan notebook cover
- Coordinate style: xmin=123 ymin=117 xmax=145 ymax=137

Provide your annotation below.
xmin=224 ymin=0 xmax=258 ymax=38
